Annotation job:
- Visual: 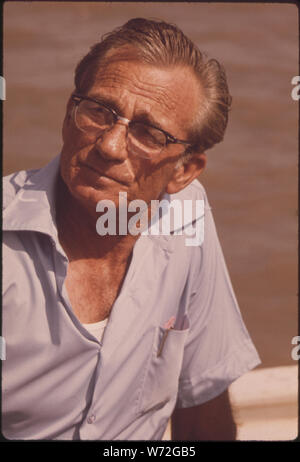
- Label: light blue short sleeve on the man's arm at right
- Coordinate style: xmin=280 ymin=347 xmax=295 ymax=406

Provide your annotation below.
xmin=176 ymin=188 xmax=261 ymax=408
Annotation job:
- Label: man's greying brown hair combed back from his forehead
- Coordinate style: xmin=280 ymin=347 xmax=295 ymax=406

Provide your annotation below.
xmin=75 ymin=18 xmax=232 ymax=155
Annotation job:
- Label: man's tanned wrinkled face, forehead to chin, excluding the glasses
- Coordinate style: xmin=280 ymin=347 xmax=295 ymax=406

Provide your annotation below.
xmin=61 ymin=56 xmax=200 ymax=211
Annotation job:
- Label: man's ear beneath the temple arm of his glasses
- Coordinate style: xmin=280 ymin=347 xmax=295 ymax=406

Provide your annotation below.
xmin=166 ymin=152 xmax=206 ymax=194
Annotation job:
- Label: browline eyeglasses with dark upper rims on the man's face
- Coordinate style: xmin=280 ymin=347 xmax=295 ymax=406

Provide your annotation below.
xmin=72 ymin=94 xmax=192 ymax=158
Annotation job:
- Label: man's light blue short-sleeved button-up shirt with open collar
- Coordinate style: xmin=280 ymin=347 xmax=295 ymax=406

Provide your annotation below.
xmin=2 ymin=156 xmax=260 ymax=440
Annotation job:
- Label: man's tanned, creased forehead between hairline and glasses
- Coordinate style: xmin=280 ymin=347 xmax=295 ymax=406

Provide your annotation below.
xmin=89 ymin=57 xmax=199 ymax=129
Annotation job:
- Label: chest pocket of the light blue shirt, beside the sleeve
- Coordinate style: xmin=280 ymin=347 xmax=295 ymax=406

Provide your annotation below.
xmin=137 ymin=317 xmax=189 ymax=414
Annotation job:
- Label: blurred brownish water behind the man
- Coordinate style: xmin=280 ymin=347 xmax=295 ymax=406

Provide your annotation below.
xmin=3 ymin=2 xmax=298 ymax=366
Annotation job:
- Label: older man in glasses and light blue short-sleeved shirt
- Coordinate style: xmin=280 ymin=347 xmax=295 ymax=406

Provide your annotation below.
xmin=2 ymin=19 xmax=259 ymax=440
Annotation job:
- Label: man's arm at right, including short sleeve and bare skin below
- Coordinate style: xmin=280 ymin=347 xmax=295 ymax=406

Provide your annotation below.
xmin=172 ymin=185 xmax=260 ymax=441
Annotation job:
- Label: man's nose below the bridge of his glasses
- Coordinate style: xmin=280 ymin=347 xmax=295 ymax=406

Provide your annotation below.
xmin=95 ymin=122 xmax=127 ymax=161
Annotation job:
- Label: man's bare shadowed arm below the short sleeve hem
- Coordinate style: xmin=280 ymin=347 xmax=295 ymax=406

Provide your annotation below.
xmin=171 ymin=390 xmax=236 ymax=441
